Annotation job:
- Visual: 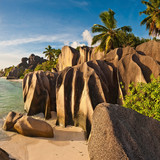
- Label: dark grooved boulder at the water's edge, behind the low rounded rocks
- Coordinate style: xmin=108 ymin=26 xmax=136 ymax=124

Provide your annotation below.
xmin=23 ymin=71 xmax=58 ymax=119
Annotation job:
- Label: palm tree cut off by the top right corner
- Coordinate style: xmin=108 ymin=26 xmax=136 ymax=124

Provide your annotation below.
xmin=140 ymin=0 xmax=160 ymax=37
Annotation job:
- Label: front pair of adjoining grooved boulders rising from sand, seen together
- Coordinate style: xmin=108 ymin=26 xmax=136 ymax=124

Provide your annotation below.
xmin=23 ymin=61 xmax=117 ymax=133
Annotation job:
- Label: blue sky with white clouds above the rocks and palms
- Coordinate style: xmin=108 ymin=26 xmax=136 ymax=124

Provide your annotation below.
xmin=0 ymin=0 xmax=149 ymax=69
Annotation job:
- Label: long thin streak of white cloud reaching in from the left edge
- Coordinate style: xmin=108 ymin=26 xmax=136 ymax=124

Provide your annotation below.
xmin=0 ymin=34 xmax=69 ymax=47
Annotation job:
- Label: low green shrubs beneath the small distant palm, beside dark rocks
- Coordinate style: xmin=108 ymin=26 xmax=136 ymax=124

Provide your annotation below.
xmin=34 ymin=59 xmax=58 ymax=71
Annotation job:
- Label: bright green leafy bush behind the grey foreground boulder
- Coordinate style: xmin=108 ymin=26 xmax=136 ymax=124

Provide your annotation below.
xmin=123 ymin=76 xmax=160 ymax=121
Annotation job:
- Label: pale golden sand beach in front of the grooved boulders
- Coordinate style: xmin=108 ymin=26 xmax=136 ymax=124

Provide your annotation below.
xmin=0 ymin=112 xmax=89 ymax=160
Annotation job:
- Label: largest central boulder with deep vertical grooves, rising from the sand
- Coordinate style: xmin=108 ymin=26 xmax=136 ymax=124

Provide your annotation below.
xmin=56 ymin=61 xmax=116 ymax=136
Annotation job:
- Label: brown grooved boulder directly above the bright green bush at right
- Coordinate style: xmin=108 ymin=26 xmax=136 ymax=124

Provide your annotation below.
xmin=117 ymin=53 xmax=160 ymax=104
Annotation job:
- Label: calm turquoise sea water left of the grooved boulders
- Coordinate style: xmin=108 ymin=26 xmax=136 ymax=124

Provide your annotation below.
xmin=0 ymin=78 xmax=23 ymax=118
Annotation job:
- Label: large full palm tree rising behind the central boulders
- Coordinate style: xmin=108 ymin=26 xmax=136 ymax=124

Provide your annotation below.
xmin=92 ymin=9 xmax=132 ymax=53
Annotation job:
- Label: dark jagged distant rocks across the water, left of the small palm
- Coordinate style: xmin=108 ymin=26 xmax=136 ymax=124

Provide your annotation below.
xmin=7 ymin=54 xmax=46 ymax=79
